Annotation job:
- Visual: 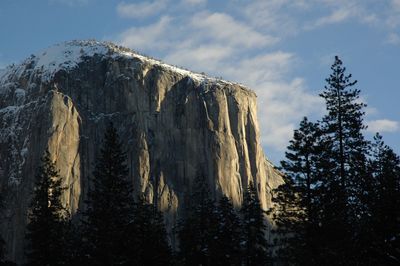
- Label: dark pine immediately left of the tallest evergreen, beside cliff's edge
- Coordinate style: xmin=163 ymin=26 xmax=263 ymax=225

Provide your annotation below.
xmin=270 ymin=117 xmax=328 ymax=265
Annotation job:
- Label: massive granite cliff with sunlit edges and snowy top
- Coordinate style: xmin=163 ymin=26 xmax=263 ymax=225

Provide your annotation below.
xmin=0 ymin=41 xmax=282 ymax=262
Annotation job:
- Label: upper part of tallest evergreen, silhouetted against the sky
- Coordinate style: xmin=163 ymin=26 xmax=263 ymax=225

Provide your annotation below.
xmin=320 ymin=56 xmax=368 ymax=191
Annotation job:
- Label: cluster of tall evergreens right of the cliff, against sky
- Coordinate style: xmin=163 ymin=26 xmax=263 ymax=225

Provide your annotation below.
xmin=272 ymin=57 xmax=400 ymax=265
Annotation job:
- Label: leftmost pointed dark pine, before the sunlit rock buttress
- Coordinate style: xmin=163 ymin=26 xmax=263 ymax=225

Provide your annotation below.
xmin=26 ymin=151 xmax=68 ymax=266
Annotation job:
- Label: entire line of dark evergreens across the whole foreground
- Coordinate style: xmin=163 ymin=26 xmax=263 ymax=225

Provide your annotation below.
xmin=0 ymin=57 xmax=400 ymax=266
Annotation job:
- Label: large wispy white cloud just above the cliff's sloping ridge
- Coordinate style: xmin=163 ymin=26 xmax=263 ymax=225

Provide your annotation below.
xmin=118 ymin=12 xmax=277 ymax=66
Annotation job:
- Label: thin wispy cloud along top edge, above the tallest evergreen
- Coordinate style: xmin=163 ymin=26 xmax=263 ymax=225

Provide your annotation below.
xmin=242 ymin=0 xmax=380 ymax=37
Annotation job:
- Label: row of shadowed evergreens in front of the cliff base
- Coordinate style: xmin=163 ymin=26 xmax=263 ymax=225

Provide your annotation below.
xmin=18 ymin=125 xmax=271 ymax=266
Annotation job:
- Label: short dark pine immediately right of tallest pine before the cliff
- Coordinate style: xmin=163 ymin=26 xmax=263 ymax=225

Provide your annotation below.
xmin=128 ymin=196 xmax=172 ymax=266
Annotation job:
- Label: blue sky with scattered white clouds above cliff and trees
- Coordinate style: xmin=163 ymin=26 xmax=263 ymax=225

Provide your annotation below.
xmin=0 ymin=0 xmax=400 ymax=163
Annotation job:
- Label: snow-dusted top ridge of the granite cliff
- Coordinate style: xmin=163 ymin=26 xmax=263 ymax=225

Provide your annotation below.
xmin=0 ymin=40 xmax=247 ymax=89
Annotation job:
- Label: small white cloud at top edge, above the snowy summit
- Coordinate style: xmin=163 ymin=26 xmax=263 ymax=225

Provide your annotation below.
xmin=117 ymin=0 xmax=167 ymax=18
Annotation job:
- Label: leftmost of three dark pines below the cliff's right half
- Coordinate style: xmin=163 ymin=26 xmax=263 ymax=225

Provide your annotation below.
xmin=178 ymin=177 xmax=217 ymax=266
